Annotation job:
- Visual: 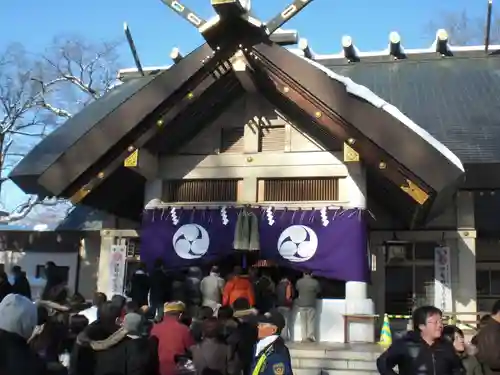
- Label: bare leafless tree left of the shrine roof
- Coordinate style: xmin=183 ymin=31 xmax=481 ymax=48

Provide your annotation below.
xmin=0 ymin=36 xmax=122 ymax=224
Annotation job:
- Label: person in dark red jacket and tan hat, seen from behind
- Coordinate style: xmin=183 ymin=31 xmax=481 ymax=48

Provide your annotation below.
xmin=151 ymin=301 xmax=195 ymax=375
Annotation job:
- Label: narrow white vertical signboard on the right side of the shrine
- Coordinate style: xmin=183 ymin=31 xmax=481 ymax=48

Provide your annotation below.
xmin=434 ymin=247 xmax=453 ymax=312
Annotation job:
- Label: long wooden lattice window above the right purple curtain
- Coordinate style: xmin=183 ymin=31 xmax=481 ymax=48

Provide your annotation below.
xmin=258 ymin=177 xmax=339 ymax=202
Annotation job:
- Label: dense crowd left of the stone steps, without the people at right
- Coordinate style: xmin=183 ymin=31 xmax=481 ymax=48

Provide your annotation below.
xmin=0 ymin=262 xmax=312 ymax=375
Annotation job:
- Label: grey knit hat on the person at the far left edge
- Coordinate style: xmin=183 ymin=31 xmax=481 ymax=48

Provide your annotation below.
xmin=0 ymin=294 xmax=38 ymax=340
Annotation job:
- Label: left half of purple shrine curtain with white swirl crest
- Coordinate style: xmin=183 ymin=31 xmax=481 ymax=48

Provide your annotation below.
xmin=140 ymin=208 xmax=237 ymax=268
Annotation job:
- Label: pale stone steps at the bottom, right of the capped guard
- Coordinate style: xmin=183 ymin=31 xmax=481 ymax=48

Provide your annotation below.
xmin=288 ymin=343 xmax=382 ymax=375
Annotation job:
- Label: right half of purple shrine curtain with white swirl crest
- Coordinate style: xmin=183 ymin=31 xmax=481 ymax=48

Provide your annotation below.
xmin=260 ymin=209 xmax=369 ymax=281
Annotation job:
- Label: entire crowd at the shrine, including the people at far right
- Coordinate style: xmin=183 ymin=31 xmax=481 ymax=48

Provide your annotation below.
xmin=6 ymin=262 xmax=500 ymax=375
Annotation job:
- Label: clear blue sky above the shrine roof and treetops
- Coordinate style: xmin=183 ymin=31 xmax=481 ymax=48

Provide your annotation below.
xmin=0 ymin=0 xmax=487 ymax=212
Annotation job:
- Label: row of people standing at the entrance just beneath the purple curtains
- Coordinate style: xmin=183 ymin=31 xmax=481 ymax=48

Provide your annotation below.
xmin=127 ymin=260 xmax=321 ymax=342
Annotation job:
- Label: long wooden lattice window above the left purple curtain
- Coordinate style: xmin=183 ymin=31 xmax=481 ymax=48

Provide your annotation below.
xmin=162 ymin=179 xmax=239 ymax=202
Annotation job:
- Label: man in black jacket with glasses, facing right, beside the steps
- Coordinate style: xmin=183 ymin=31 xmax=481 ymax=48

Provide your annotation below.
xmin=377 ymin=306 xmax=465 ymax=375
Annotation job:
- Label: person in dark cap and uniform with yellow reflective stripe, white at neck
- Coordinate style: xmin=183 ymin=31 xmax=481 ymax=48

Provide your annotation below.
xmin=250 ymin=310 xmax=293 ymax=375
